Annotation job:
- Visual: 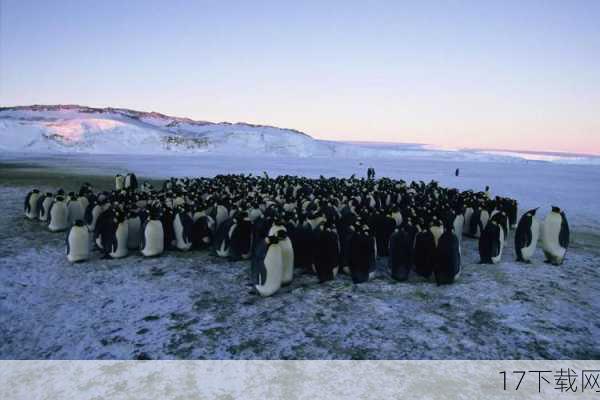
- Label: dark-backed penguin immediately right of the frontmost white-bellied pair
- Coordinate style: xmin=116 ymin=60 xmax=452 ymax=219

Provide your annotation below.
xmin=315 ymin=222 xmax=340 ymax=283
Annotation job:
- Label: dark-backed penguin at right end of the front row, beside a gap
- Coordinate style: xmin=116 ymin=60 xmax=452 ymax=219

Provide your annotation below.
xmin=433 ymin=230 xmax=461 ymax=286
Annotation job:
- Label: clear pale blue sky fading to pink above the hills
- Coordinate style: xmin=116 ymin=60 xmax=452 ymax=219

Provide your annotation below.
xmin=0 ymin=0 xmax=600 ymax=154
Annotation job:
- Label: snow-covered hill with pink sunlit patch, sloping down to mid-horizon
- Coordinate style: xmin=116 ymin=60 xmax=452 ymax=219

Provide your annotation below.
xmin=0 ymin=106 xmax=333 ymax=156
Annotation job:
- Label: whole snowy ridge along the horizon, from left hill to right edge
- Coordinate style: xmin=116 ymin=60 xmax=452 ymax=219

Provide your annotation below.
xmin=0 ymin=105 xmax=600 ymax=165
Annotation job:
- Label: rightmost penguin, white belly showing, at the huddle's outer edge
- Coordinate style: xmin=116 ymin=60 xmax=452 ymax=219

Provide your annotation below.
xmin=542 ymin=207 xmax=570 ymax=265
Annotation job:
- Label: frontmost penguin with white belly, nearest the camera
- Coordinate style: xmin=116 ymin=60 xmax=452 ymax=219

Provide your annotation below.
xmin=251 ymin=236 xmax=283 ymax=297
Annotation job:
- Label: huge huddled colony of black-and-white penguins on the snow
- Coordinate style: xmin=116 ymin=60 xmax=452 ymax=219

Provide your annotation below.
xmin=24 ymin=173 xmax=569 ymax=296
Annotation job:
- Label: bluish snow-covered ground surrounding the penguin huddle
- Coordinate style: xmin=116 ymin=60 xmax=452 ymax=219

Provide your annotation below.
xmin=0 ymin=154 xmax=600 ymax=359
